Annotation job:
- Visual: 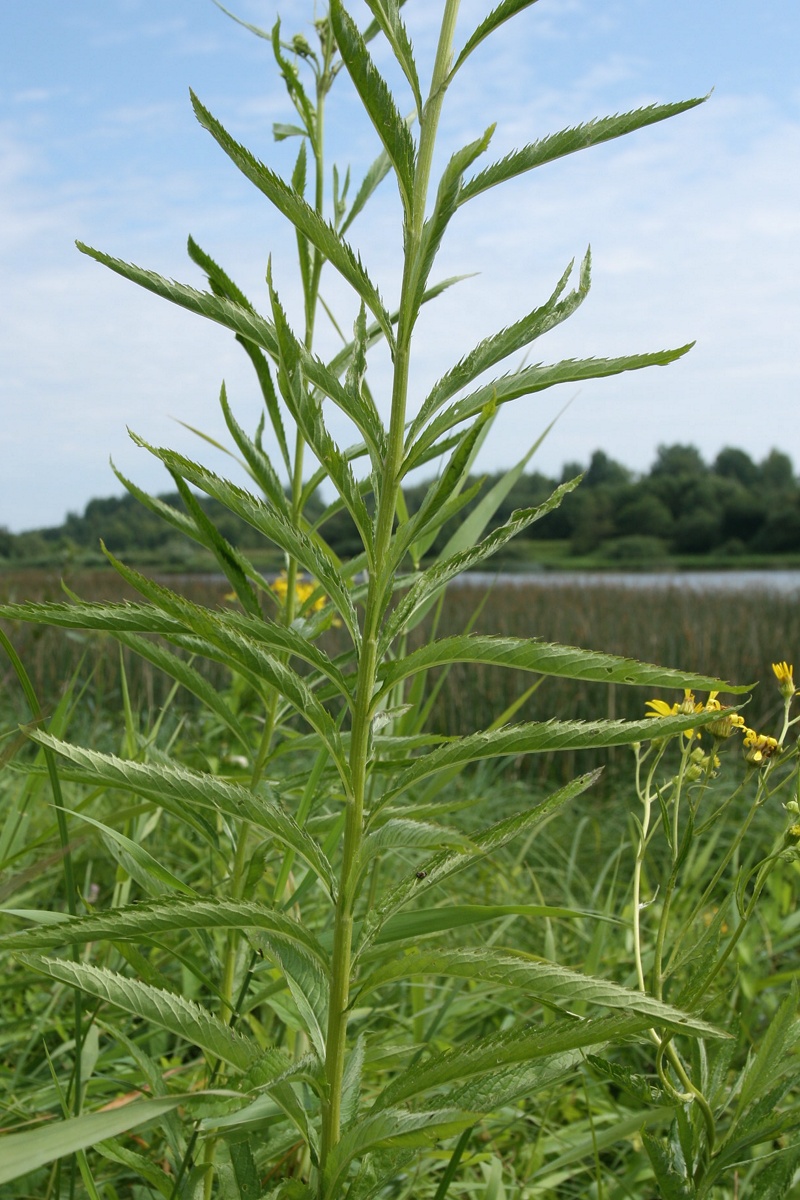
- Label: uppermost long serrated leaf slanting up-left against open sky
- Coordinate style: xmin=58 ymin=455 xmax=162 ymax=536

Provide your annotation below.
xmin=191 ymin=92 xmax=395 ymax=349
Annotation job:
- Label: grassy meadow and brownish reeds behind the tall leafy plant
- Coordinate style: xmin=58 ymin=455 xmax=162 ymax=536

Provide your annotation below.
xmin=0 ymin=572 xmax=800 ymax=1200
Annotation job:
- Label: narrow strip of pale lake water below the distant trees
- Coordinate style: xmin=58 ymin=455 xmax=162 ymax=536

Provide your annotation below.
xmin=455 ymin=570 xmax=800 ymax=595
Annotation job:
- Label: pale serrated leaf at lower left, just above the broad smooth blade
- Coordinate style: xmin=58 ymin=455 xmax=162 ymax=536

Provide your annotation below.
xmin=18 ymin=954 xmax=259 ymax=1070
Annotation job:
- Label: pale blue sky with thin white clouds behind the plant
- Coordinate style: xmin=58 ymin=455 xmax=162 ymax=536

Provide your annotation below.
xmin=0 ymin=0 xmax=800 ymax=532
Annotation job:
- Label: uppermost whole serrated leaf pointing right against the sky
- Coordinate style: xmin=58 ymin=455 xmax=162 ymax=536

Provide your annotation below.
xmin=458 ymin=96 xmax=706 ymax=204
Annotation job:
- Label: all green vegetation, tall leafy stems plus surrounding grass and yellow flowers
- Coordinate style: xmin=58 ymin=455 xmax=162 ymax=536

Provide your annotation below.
xmin=0 ymin=0 xmax=800 ymax=1200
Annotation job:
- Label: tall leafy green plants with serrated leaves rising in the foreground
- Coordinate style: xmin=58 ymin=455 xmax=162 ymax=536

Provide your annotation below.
xmin=0 ymin=0 xmax=741 ymax=1200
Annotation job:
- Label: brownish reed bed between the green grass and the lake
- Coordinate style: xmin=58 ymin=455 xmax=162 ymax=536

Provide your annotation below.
xmin=0 ymin=570 xmax=800 ymax=753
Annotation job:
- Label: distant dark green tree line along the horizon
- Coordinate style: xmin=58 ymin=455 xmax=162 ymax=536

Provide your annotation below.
xmin=0 ymin=445 xmax=800 ymax=564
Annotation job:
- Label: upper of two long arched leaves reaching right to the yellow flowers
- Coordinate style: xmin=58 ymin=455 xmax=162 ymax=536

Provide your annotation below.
xmin=380 ymin=634 xmax=748 ymax=694
